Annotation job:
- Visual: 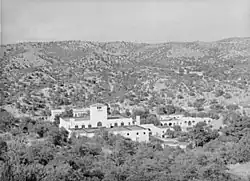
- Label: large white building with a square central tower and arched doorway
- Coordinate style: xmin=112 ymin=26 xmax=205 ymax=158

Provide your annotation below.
xmin=59 ymin=104 xmax=149 ymax=142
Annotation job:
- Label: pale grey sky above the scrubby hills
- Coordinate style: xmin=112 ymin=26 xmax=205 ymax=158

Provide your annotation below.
xmin=1 ymin=0 xmax=250 ymax=44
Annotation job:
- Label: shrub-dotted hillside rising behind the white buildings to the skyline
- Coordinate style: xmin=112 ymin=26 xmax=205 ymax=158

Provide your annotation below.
xmin=1 ymin=38 xmax=250 ymax=116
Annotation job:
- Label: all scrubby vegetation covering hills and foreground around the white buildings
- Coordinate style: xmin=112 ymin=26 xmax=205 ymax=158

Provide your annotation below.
xmin=0 ymin=38 xmax=250 ymax=181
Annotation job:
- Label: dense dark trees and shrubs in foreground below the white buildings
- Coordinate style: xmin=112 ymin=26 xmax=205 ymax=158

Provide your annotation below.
xmin=0 ymin=108 xmax=250 ymax=181
